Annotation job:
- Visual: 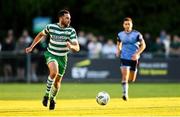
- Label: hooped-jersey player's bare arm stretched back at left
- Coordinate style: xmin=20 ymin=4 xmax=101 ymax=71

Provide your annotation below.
xmin=26 ymin=31 xmax=46 ymax=53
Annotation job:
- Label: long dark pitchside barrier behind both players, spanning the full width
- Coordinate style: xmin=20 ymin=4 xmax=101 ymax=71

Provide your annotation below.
xmin=0 ymin=52 xmax=180 ymax=83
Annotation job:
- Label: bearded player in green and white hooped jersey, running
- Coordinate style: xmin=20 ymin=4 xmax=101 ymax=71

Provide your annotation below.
xmin=26 ymin=10 xmax=80 ymax=110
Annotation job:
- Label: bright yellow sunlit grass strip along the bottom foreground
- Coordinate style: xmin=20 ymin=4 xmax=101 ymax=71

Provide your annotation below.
xmin=0 ymin=97 xmax=180 ymax=116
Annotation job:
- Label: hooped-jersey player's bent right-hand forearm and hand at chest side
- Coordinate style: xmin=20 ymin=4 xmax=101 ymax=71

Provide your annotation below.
xmin=67 ymin=40 xmax=80 ymax=52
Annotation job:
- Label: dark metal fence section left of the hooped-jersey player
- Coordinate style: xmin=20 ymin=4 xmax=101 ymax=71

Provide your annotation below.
xmin=0 ymin=52 xmax=48 ymax=83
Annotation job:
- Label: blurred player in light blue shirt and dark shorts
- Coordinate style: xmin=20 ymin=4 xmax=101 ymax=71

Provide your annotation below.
xmin=116 ymin=17 xmax=146 ymax=101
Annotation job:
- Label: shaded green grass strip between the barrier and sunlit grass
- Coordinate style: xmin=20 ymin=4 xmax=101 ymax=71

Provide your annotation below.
xmin=0 ymin=82 xmax=180 ymax=100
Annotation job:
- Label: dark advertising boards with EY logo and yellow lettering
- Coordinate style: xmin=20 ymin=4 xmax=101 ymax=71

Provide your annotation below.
xmin=65 ymin=58 xmax=180 ymax=82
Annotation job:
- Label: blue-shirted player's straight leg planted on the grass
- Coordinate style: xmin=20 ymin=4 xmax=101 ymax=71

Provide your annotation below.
xmin=121 ymin=66 xmax=130 ymax=100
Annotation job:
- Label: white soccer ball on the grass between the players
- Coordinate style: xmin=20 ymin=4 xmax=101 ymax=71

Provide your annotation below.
xmin=96 ymin=91 xmax=110 ymax=105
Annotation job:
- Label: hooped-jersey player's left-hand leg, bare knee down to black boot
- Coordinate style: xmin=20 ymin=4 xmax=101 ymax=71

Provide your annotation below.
xmin=43 ymin=61 xmax=58 ymax=106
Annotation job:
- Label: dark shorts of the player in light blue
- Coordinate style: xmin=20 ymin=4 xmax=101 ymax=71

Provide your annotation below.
xmin=120 ymin=59 xmax=138 ymax=71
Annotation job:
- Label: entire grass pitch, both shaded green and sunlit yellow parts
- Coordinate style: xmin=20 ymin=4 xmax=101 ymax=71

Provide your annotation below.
xmin=0 ymin=82 xmax=180 ymax=117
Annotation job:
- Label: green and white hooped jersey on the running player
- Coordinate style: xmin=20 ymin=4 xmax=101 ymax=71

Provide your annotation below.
xmin=42 ymin=23 xmax=77 ymax=56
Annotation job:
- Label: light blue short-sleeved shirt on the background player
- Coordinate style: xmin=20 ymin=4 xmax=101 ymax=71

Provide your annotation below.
xmin=118 ymin=30 xmax=143 ymax=60
